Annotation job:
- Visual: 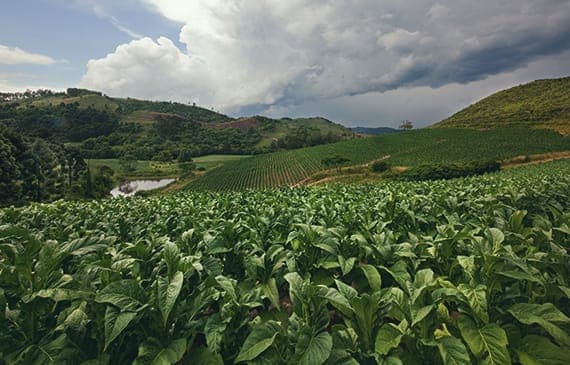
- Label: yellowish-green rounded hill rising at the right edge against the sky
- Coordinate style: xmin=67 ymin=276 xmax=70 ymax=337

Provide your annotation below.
xmin=433 ymin=77 xmax=570 ymax=135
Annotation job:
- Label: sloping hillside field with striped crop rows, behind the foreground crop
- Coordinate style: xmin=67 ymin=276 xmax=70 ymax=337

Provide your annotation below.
xmin=190 ymin=128 xmax=570 ymax=191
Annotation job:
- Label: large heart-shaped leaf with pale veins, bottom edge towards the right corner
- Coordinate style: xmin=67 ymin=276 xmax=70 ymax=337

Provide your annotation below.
xmin=458 ymin=315 xmax=511 ymax=365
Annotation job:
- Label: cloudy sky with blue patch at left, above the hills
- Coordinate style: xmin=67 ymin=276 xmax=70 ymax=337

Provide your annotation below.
xmin=0 ymin=0 xmax=570 ymax=127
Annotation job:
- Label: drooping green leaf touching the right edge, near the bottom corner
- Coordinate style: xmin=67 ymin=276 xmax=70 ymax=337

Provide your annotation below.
xmin=509 ymin=303 xmax=570 ymax=346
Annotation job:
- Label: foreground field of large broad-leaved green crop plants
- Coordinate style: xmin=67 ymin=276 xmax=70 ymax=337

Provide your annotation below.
xmin=0 ymin=161 xmax=570 ymax=365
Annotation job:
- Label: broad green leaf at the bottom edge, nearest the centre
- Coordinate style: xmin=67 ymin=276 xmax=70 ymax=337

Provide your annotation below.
xmin=294 ymin=329 xmax=332 ymax=365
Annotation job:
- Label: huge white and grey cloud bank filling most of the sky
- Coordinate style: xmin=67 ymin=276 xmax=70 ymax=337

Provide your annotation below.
xmin=81 ymin=0 xmax=570 ymax=112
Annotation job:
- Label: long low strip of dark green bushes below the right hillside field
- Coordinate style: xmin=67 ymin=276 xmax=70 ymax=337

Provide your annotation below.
xmin=400 ymin=161 xmax=501 ymax=181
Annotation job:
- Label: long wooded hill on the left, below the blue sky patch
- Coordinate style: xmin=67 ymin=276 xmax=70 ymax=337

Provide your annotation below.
xmin=0 ymin=88 xmax=356 ymax=161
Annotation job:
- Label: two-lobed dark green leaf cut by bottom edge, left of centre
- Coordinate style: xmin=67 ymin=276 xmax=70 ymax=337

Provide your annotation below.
xmin=133 ymin=338 xmax=186 ymax=365
